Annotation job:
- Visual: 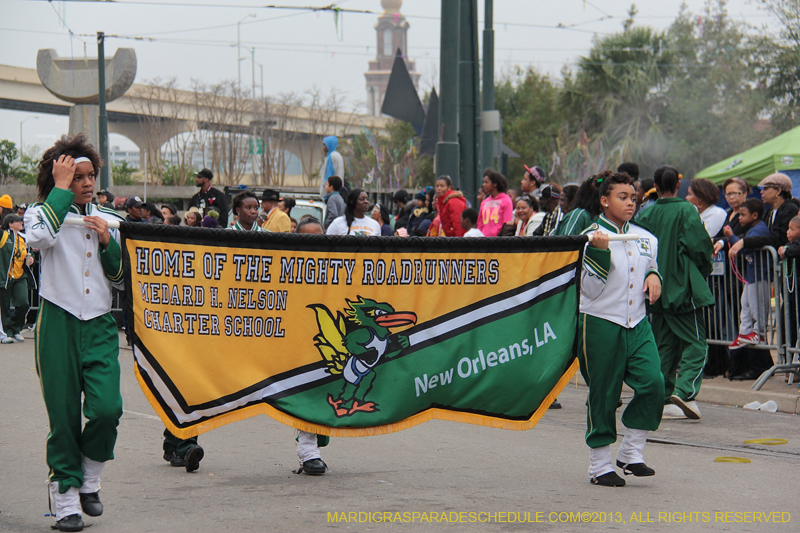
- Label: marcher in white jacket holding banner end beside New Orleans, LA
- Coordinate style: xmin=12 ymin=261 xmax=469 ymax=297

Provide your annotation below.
xmin=578 ymin=174 xmax=664 ymax=487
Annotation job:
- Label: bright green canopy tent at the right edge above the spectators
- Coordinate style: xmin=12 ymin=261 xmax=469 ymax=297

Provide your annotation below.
xmin=695 ymin=127 xmax=800 ymax=197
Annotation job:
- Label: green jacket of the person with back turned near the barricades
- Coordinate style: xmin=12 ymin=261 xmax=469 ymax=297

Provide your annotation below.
xmin=636 ymin=198 xmax=714 ymax=314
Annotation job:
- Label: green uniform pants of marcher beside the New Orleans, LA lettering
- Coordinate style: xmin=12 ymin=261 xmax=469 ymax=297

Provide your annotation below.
xmin=578 ymin=313 xmax=664 ymax=448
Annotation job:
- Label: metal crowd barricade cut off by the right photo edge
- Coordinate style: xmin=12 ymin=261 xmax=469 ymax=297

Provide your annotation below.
xmin=750 ymin=259 xmax=800 ymax=390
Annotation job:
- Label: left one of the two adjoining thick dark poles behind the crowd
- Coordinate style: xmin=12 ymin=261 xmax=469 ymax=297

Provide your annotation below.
xmin=434 ymin=0 xmax=462 ymax=187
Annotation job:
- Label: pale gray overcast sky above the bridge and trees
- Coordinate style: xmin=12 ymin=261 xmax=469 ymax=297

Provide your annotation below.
xmin=0 ymin=0 xmax=772 ymax=154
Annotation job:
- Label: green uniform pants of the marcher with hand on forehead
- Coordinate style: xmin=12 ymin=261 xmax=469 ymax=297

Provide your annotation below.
xmin=36 ymin=299 xmax=122 ymax=494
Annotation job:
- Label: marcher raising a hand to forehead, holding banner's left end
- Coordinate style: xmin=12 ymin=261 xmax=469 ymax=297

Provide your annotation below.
xmin=25 ymin=134 xmax=122 ymax=531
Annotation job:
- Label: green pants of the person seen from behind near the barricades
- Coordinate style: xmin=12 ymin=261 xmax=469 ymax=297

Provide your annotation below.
xmin=653 ymin=309 xmax=708 ymax=405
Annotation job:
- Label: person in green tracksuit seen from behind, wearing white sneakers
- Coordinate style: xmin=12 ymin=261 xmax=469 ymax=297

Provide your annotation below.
xmin=636 ymin=166 xmax=714 ymax=420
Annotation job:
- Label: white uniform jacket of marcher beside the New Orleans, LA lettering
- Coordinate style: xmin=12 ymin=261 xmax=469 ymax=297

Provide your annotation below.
xmin=581 ymin=215 xmax=661 ymax=328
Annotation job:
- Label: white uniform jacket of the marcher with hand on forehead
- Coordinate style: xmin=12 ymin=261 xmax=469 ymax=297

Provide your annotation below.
xmin=25 ymin=188 xmax=123 ymax=320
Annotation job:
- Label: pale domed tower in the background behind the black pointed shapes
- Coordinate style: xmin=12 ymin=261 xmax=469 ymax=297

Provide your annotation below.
xmin=364 ymin=0 xmax=420 ymax=116
